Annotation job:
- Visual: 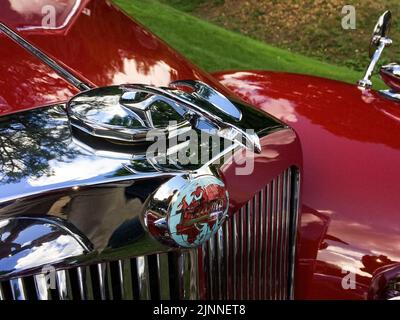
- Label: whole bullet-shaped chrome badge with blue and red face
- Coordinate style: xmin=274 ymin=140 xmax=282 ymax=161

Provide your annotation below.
xmin=144 ymin=175 xmax=229 ymax=248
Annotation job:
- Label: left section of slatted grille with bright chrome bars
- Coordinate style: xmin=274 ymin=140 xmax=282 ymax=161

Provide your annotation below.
xmin=0 ymin=250 xmax=198 ymax=300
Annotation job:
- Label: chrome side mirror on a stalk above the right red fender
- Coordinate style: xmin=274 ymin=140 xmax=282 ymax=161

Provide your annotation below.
xmin=358 ymin=11 xmax=392 ymax=88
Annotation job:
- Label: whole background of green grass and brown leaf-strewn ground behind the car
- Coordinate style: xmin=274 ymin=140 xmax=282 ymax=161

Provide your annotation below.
xmin=115 ymin=0 xmax=400 ymax=87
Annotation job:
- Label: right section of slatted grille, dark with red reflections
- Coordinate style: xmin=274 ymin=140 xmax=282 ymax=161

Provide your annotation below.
xmin=199 ymin=169 xmax=298 ymax=299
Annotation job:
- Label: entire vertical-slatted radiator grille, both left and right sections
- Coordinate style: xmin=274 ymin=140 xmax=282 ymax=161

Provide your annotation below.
xmin=0 ymin=168 xmax=299 ymax=300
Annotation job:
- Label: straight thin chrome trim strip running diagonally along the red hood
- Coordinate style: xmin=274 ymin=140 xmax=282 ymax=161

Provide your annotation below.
xmin=0 ymin=22 xmax=90 ymax=91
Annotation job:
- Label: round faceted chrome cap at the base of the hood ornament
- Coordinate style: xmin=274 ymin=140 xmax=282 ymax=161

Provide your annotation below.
xmin=67 ymin=85 xmax=191 ymax=143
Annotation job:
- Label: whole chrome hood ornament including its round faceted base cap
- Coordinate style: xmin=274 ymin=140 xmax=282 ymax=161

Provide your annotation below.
xmin=67 ymin=80 xmax=261 ymax=153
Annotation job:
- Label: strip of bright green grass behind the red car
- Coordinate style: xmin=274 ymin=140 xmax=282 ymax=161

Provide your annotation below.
xmin=114 ymin=0 xmax=382 ymax=87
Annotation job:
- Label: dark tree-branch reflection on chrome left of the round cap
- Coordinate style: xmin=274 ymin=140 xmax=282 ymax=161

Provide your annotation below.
xmin=0 ymin=108 xmax=74 ymax=183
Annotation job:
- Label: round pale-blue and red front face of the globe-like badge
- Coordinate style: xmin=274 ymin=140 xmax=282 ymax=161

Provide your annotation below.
xmin=168 ymin=176 xmax=229 ymax=248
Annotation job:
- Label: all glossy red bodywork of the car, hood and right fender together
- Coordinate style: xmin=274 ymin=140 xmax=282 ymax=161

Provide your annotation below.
xmin=0 ymin=0 xmax=400 ymax=299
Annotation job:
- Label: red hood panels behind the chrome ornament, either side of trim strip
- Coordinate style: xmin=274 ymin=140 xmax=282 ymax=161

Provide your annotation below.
xmin=0 ymin=0 xmax=226 ymax=115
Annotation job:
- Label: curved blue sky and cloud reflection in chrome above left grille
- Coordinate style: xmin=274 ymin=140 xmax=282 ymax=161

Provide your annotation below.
xmin=0 ymin=217 xmax=91 ymax=280
